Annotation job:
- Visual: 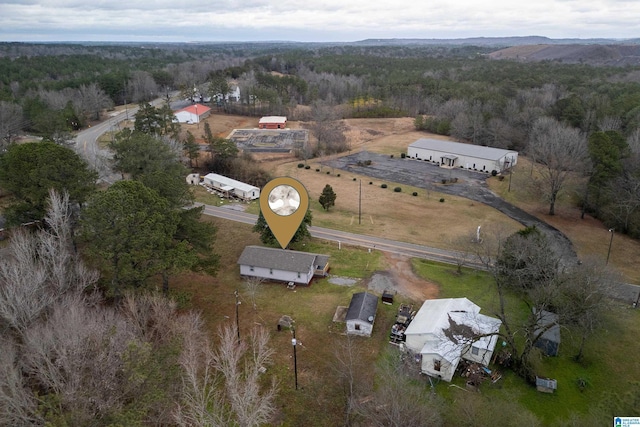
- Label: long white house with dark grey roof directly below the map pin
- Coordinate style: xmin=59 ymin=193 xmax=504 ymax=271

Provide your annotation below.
xmin=238 ymin=246 xmax=329 ymax=285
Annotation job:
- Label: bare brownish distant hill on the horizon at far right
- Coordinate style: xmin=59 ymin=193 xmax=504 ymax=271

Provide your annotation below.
xmin=487 ymin=44 xmax=640 ymax=66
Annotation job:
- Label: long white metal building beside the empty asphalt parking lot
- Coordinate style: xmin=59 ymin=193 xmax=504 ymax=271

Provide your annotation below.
xmin=407 ymin=138 xmax=518 ymax=173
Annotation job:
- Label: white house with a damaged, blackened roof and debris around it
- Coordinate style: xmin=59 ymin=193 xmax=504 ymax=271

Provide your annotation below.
xmin=404 ymin=298 xmax=502 ymax=381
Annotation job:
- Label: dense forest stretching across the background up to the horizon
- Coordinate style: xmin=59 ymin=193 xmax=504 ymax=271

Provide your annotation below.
xmin=0 ymin=43 xmax=640 ymax=237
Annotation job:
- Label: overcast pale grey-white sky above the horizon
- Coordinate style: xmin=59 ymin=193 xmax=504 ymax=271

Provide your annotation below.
xmin=0 ymin=0 xmax=640 ymax=42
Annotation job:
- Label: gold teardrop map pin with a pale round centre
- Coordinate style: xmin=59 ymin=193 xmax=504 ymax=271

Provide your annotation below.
xmin=260 ymin=177 xmax=309 ymax=249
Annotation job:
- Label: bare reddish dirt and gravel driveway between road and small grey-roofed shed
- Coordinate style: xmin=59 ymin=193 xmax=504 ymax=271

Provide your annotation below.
xmin=365 ymin=252 xmax=440 ymax=303
